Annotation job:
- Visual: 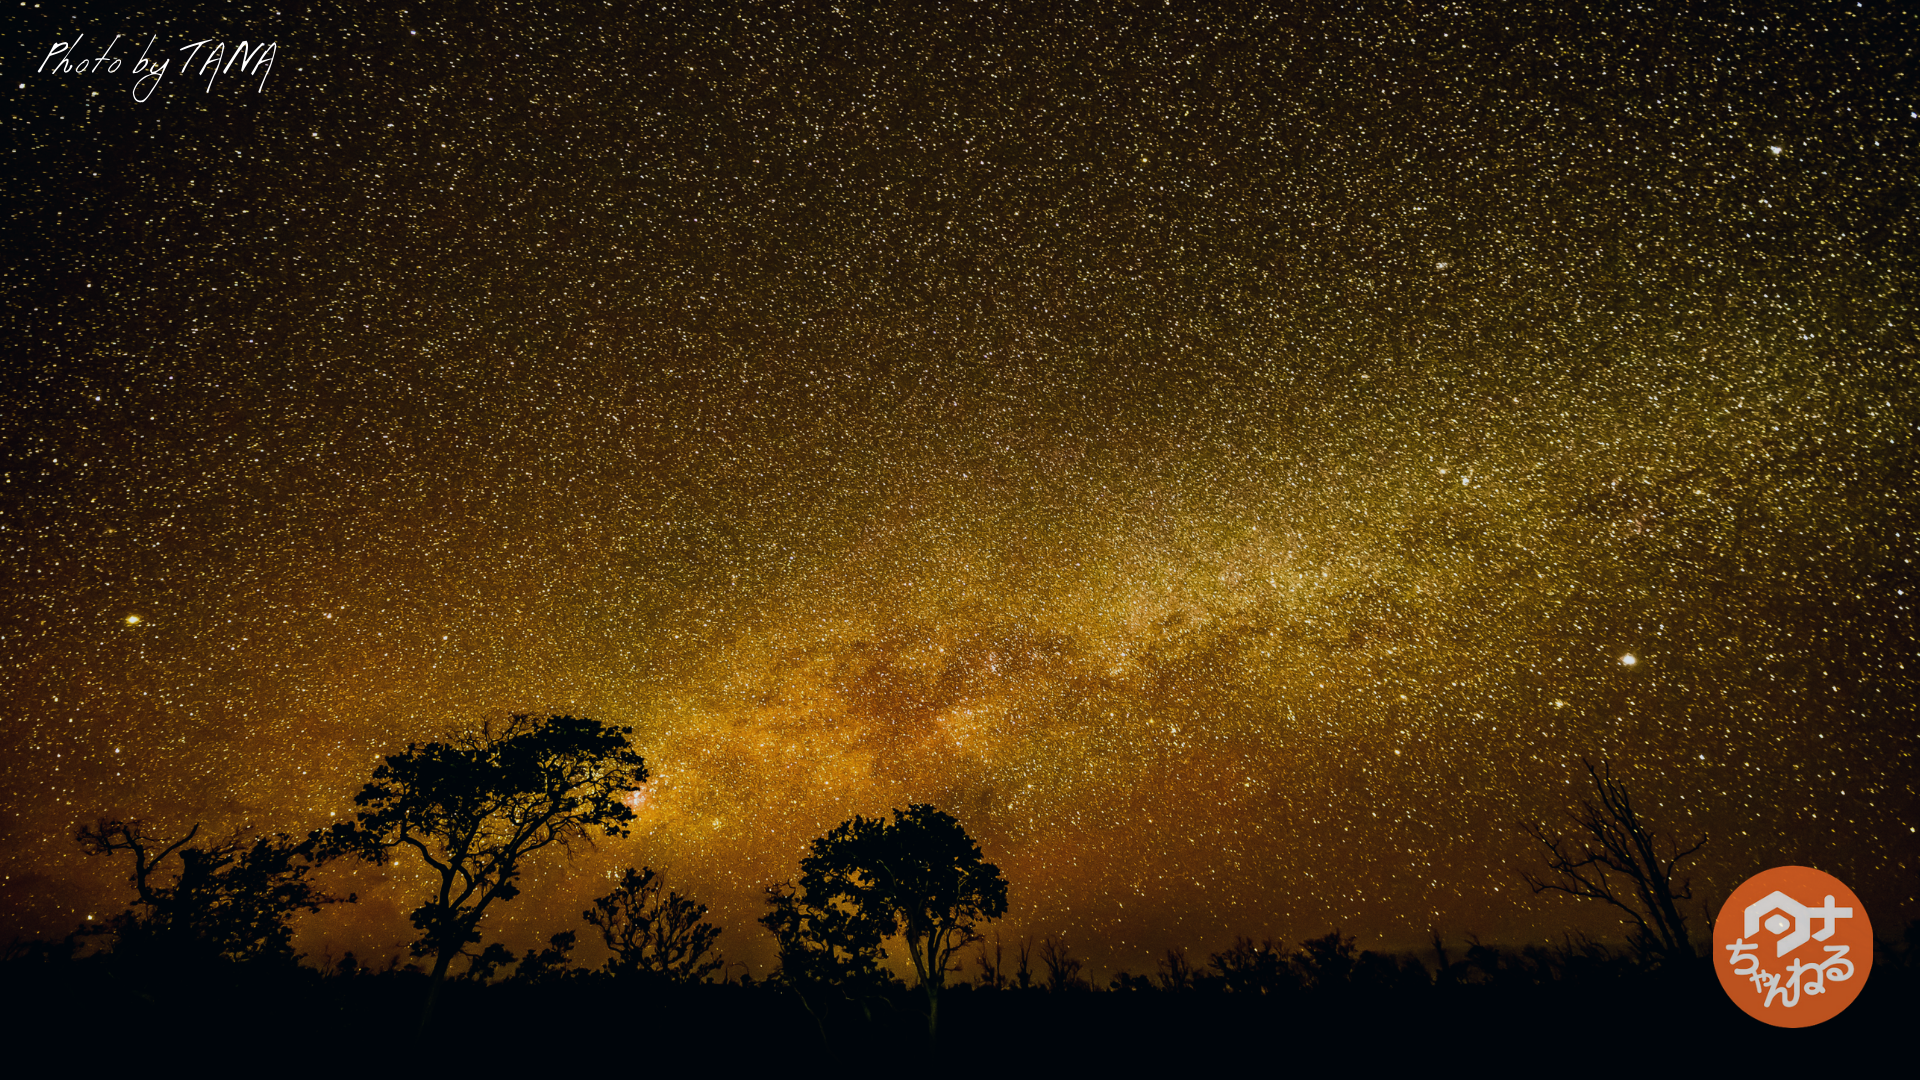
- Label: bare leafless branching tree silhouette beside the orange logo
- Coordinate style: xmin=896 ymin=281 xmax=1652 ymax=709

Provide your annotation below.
xmin=1521 ymin=759 xmax=1707 ymax=963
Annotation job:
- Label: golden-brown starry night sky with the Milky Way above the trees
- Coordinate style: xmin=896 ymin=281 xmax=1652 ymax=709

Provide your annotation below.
xmin=0 ymin=0 xmax=1920 ymax=974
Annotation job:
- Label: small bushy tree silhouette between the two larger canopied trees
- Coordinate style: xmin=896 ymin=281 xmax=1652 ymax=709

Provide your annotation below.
xmin=582 ymin=867 xmax=724 ymax=982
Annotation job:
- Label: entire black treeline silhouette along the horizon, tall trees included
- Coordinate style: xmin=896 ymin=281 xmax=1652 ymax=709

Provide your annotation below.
xmin=0 ymin=717 xmax=1920 ymax=1067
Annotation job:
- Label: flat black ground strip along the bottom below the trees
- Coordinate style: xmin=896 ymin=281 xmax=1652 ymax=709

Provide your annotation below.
xmin=0 ymin=949 xmax=1920 ymax=1076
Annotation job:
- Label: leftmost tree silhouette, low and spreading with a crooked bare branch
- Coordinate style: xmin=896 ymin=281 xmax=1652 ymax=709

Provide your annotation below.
xmin=79 ymin=819 xmax=355 ymax=963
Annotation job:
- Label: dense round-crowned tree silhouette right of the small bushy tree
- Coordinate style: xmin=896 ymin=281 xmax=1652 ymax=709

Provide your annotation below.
xmin=760 ymin=803 xmax=1006 ymax=1034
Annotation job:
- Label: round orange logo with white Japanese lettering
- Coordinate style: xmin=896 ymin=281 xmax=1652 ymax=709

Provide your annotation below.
xmin=1713 ymin=867 xmax=1874 ymax=1028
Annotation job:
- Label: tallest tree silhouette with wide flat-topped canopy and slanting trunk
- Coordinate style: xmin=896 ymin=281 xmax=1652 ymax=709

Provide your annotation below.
xmin=330 ymin=715 xmax=647 ymax=1026
